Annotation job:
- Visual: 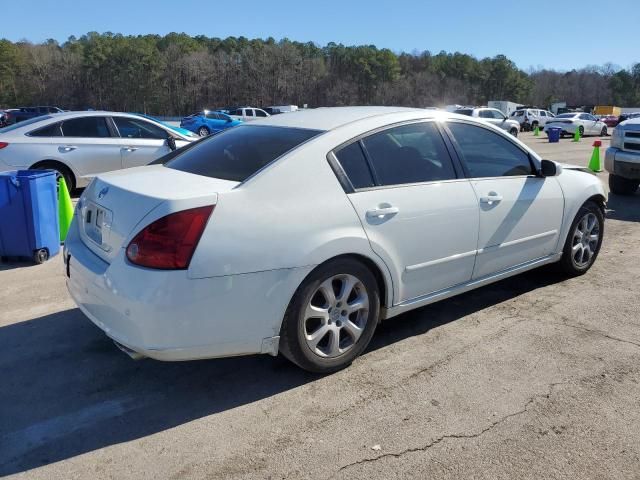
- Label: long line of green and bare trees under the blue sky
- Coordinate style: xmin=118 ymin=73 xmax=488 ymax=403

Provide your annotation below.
xmin=0 ymin=32 xmax=640 ymax=115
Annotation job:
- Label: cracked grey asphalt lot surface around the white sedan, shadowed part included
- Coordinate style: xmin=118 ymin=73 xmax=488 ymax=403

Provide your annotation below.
xmin=0 ymin=129 xmax=640 ymax=479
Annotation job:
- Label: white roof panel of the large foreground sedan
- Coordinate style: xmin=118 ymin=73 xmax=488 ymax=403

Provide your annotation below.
xmin=252 ymin=107 xmax=430 ymax=130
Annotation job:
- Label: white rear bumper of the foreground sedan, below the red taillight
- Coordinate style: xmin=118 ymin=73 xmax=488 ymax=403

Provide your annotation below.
xmin=65 ymin=218 xmax=311 ymax=361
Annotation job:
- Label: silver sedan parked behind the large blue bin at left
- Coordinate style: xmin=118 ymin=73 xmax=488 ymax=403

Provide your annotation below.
xmin=0 ymin=111 xmax=197 ymax=190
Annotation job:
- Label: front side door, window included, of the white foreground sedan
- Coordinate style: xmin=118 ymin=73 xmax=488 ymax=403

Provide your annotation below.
xmin=448 ymin=121 xmax=564 ymax=279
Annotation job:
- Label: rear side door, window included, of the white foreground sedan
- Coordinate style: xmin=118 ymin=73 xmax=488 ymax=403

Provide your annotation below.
xmin=335 ymin=121 xmax=478 ymax=304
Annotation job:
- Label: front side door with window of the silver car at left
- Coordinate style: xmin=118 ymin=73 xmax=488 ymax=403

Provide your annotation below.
xmin=112 ymin=116 xmax=171 ymax=168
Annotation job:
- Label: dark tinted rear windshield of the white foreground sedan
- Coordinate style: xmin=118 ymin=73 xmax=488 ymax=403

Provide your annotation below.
xmin=165 ymin=125 xmax=322 ymax=182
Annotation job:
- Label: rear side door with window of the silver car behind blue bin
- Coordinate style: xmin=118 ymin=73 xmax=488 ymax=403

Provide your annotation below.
xmin=57 ymin=116 xmax=122 ymax=177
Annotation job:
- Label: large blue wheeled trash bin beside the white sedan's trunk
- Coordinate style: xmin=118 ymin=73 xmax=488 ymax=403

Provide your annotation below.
xmin=0 ymin=170 xmax=60 ymax=263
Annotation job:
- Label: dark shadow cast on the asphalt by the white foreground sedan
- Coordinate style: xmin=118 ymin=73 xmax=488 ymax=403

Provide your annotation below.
xmin=0 ymin=268 xmax=563 ymax=476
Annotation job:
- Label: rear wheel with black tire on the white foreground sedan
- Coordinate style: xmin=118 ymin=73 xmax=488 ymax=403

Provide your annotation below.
xmin=280 ymin=257 xmax=380 ymax=374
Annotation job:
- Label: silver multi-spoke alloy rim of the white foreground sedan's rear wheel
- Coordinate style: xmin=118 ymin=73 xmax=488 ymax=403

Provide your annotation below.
xmin=303 ymin=274 xmax=369 ymax=358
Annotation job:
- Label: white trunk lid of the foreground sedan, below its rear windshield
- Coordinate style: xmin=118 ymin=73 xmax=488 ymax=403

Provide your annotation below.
xmin=76 ymin=165 xmax=238 ymax=263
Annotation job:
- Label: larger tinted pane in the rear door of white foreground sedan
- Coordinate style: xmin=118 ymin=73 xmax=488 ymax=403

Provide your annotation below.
xmin=362 ymin=122 xmax=456 ymax=185
